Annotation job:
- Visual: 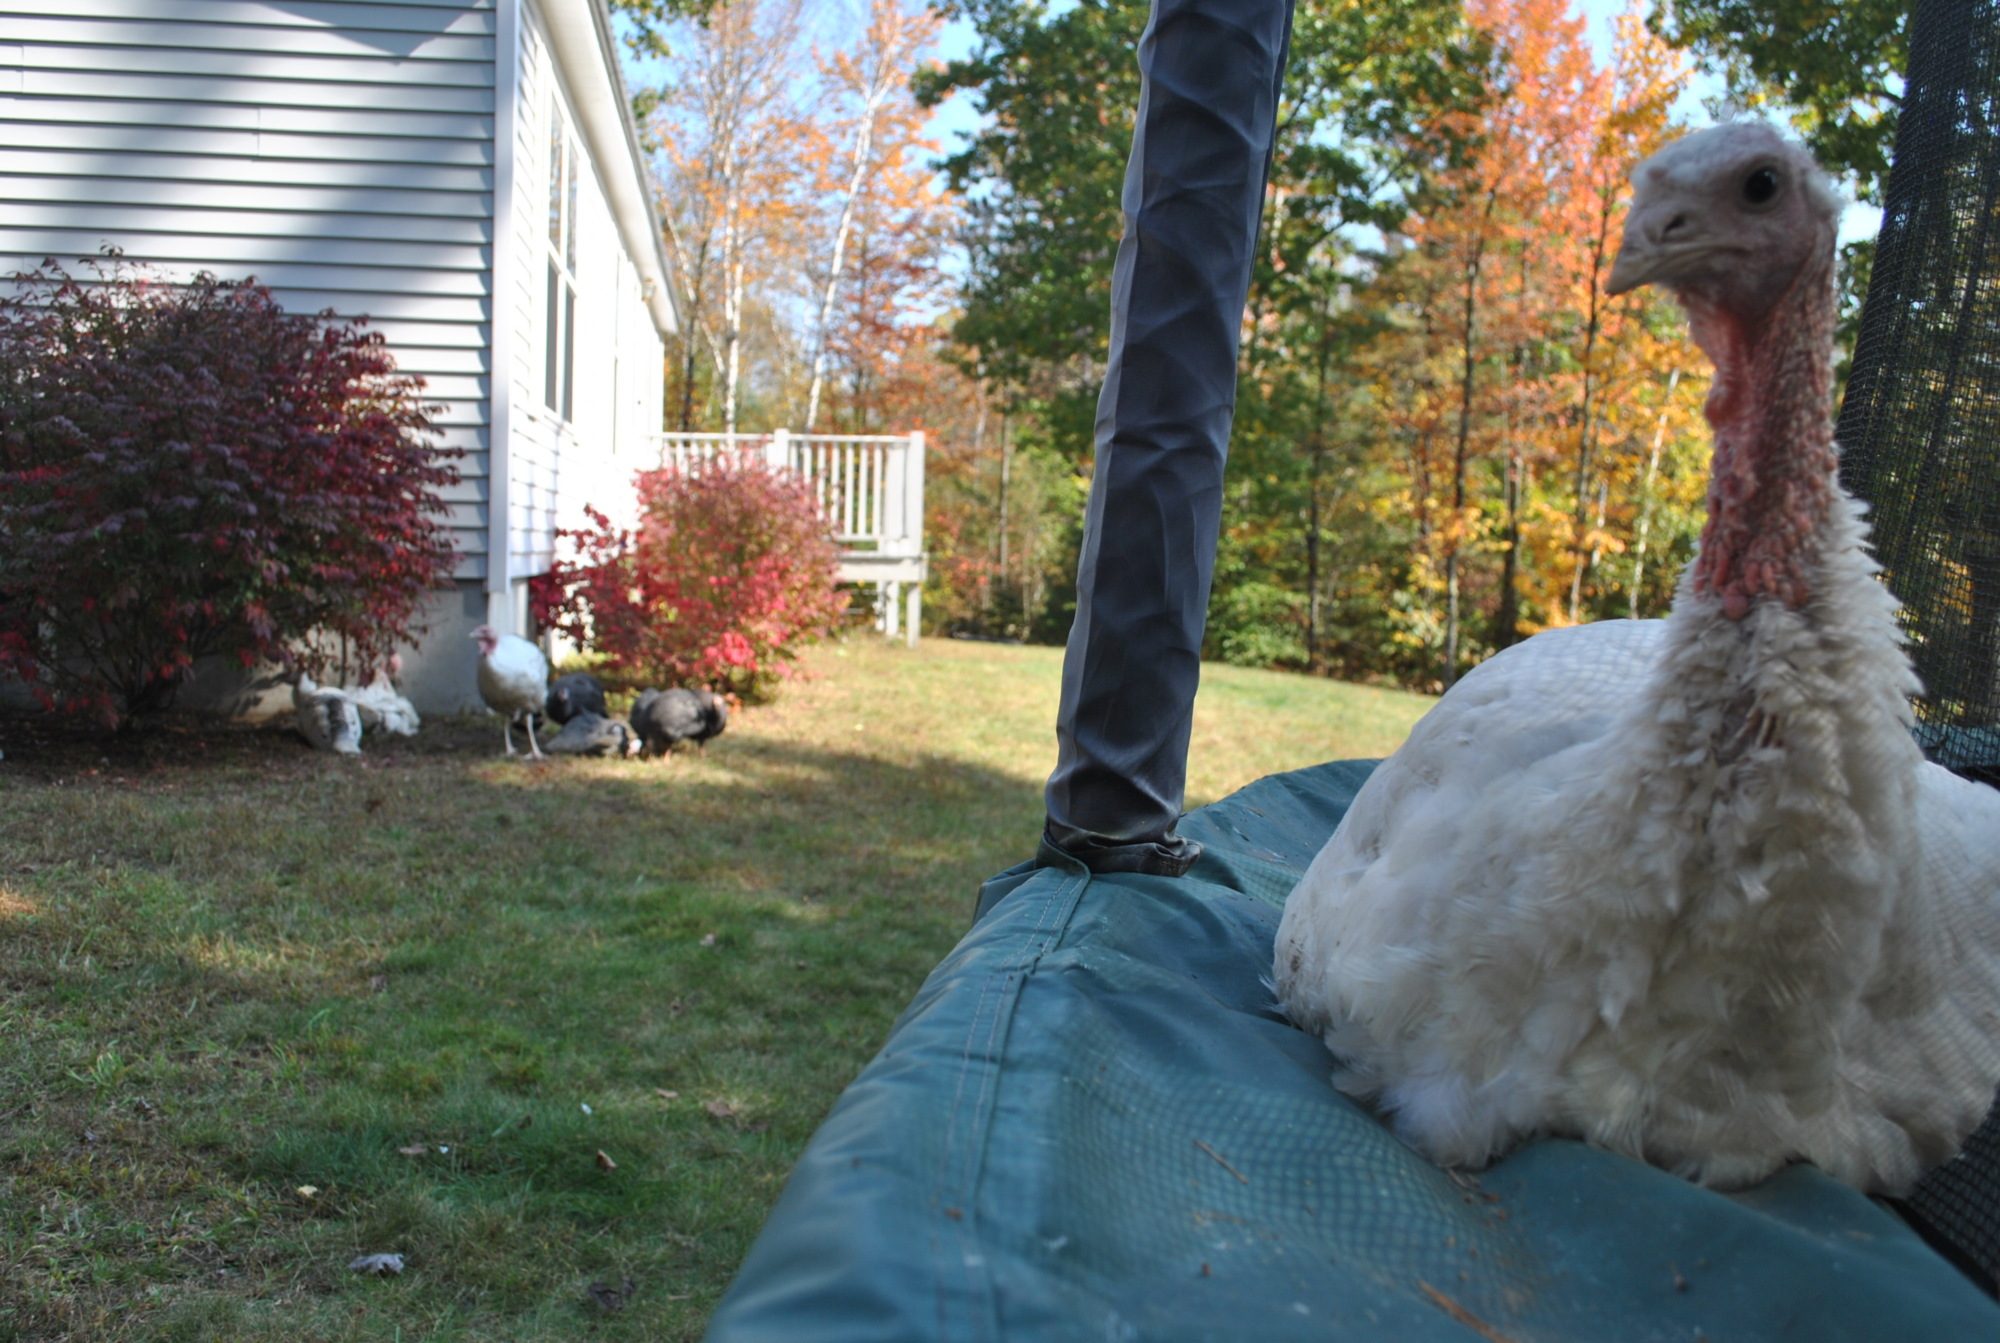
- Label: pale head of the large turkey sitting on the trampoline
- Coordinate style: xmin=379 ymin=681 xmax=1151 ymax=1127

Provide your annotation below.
xmin=1604 ymin=122 xmax=1840 ymax=326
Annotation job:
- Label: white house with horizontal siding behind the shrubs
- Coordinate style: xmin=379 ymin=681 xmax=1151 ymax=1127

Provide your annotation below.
xmin=0 ymin=0 xmax=674 ymax=709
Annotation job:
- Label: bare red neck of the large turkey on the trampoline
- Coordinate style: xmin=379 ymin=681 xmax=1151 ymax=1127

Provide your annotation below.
xmin=1684 ymin=256 xmax=1840 ymax=620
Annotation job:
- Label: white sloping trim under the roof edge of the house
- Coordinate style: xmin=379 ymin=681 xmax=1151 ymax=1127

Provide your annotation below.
xmin=540 ymin=0 xmax=680 ymax=336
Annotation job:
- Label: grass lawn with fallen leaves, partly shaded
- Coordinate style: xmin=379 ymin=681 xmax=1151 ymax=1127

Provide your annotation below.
xmin=0 ymin=640 xmax=1424 ymax=1341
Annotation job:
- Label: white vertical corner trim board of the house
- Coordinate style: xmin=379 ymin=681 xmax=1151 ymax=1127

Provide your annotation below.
xmin=486 ymin=0 xmax=524 ymax=634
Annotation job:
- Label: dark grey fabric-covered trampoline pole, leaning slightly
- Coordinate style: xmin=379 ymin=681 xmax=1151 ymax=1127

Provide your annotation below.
xmin=1044 ymin=0 xmax=1292 ymax=875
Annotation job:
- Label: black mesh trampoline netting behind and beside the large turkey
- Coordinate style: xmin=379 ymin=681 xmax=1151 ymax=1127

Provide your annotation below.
xmin=1840 ymin=0 xmax=2000 ymax=1287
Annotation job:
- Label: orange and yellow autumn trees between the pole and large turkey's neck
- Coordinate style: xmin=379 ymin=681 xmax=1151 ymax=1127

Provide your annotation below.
xmin=1374 ymin=0 xmax=1700 ymax=681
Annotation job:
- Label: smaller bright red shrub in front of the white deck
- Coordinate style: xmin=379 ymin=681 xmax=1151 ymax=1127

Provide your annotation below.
xmin=530 ymin=454 xmax=846 ymax=695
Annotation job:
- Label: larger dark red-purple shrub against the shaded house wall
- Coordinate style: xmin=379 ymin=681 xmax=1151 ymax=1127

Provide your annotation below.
xmin=0 ymin=252 xmax=458 ymax=723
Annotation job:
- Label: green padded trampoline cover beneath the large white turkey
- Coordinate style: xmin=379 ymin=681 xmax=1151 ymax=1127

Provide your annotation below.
xmin=710 ymin=761 xmax=2000 ymax=1343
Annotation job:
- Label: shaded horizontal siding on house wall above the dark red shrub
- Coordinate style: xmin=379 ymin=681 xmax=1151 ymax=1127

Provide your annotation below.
xmin=0 ymin=0 xmax=496 ymax=580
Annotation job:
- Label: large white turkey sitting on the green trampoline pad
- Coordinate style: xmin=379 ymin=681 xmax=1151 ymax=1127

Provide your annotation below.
xmin=1274 ymin=122 xmax=2000 ymax=1193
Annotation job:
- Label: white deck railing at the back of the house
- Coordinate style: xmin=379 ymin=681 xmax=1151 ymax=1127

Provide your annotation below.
xmin=656 ymin=430 xmax=924 ymax=644
